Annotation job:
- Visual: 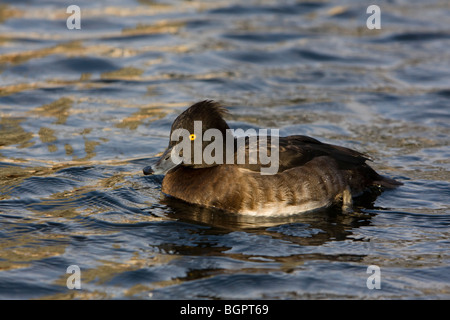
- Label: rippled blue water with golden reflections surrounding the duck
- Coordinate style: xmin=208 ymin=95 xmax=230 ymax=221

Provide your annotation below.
xmin=0 ymin=0 xmax=450 ymax=299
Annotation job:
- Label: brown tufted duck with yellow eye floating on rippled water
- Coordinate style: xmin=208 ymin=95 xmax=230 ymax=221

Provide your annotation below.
xmin=143 ymin=100 xmax=402 ymax=216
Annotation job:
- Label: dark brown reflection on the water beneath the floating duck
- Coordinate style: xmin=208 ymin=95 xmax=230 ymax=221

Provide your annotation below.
xmin=161 ymin=189 xmax=381 ymax=246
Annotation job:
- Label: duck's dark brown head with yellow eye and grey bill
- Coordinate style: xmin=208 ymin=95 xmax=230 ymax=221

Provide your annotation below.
xmin=143 ymin=100 xmax=230 ymax=175
